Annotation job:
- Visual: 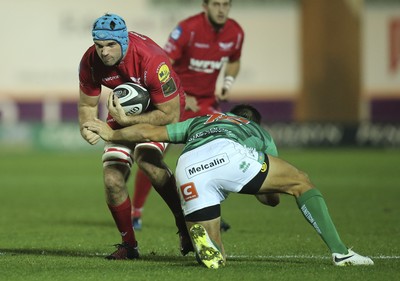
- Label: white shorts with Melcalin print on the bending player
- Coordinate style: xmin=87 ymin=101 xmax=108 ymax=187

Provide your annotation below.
xmin=176 ymin=139 xmax=264 ymax=215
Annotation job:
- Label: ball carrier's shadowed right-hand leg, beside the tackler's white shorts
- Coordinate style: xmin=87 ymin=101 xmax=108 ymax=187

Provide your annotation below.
xmin=134 ymin=143 xmax=193 ymax=255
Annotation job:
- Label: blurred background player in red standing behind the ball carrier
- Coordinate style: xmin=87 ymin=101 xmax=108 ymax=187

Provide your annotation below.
xmin=132 ymin=0 xmax=244 ymax=231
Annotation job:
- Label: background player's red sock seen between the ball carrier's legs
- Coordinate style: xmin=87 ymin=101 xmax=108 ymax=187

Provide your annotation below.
xmin=131 ymin=169 xmax=151 ymax=217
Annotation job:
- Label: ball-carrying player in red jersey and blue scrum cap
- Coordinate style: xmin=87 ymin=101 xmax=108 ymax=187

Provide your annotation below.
xmin=78 ymin=14 xmax=193 ymax=259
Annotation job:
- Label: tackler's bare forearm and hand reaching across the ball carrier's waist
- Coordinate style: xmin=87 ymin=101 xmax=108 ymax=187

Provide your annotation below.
xmin=83 ymin=119 xmax=169 ymax=144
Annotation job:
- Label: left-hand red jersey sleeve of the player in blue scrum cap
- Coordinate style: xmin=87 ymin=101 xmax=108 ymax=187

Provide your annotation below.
xmin=79 ymin=50 xmax=101 ymax=96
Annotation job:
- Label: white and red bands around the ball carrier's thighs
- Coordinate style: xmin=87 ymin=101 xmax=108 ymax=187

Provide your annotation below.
xmin=102 ymin=142 xmax=168 ymax=168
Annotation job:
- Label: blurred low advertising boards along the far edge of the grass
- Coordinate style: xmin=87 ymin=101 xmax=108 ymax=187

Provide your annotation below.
xmin=0 ymin=122 xmax=400 ymax=151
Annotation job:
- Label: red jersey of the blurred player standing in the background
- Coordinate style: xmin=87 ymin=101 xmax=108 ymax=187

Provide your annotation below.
xmin=164 ymin=12 xmax=244 ymax=117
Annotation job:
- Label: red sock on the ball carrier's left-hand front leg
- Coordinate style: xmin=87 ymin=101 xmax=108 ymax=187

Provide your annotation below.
xmin=108 ymin=196 xmax=136 ymax=247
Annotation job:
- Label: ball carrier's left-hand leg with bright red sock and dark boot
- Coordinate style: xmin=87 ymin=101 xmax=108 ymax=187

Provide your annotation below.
xmin=103 ymin=144 xmax=139 ymax=259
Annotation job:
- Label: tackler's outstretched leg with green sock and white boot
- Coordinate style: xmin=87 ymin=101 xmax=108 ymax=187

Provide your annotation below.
xmin=259 ymin=153 xmax=373 ymax=265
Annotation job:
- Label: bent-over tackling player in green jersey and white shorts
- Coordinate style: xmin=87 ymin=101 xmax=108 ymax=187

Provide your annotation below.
xmin=84 ymin=97 xmax=374 ymax=268
